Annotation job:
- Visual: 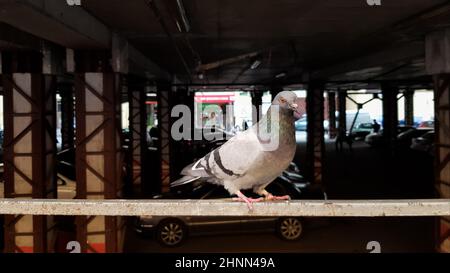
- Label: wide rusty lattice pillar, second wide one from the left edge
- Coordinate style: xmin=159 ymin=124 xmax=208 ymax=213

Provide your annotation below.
xmin=75 ymin=73 xmax=124 ymax=253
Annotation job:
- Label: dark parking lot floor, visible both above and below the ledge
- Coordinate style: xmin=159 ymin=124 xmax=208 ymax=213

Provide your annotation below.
xmin=125 ymin=135 xmax=435 ymax=253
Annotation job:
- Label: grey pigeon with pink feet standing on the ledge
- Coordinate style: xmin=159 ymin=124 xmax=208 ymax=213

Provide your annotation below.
xmin=171 ymin=91 xmax=299 ymax=210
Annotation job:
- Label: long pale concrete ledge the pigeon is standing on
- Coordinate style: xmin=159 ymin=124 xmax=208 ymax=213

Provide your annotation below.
xmin=0 ymin=199 xmax=450 ymax=217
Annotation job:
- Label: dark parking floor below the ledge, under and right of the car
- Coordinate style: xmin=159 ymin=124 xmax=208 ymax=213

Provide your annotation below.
xmin=125 ymin=218 xmax=434 ymax=253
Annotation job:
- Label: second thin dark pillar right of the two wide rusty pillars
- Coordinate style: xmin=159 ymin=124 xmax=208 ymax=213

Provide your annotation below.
xmin=158 ymin=85 xmax=172 ymax=193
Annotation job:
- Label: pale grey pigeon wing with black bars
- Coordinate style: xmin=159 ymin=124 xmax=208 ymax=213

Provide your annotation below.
xmin=181 ymin=131 xmax=263 ymax=181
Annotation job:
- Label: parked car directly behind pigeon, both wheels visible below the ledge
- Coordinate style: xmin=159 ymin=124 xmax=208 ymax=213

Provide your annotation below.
xmin=135 ymin=164 xmax=326 ymax=247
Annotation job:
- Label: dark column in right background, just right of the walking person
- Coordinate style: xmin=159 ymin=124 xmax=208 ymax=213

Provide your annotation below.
xmin=381 ymin=84 xmax=399 ymax=153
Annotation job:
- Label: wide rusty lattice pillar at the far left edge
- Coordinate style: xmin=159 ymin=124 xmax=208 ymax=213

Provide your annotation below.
xmin=3 ymin=73 xmax=57 ymax=253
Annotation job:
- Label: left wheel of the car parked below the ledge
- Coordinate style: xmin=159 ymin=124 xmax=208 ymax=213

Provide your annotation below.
xmin=156 ymin=219 xmax=187 ymax=247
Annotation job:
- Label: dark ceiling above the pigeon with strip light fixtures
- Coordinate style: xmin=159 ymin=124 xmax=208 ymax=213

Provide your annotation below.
xmin=0 ymin=0 xmax=450 ymax=84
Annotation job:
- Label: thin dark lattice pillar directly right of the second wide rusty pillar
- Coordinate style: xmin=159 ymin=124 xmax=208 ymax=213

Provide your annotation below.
xmin=128 ymin=86 xmax=147 ymax=194
